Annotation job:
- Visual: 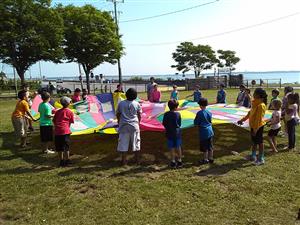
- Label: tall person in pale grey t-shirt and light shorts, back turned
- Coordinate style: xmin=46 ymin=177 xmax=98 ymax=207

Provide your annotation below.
xmin=116 ymin=88 xmax=142 ymax=166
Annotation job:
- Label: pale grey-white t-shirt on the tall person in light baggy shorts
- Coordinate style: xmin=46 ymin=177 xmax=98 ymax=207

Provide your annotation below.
xmin=117 ymin=100 xmax=142 ymax=133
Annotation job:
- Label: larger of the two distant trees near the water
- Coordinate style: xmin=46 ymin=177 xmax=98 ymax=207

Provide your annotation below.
xmin=171 ymin=42 xmax=218 ymax=78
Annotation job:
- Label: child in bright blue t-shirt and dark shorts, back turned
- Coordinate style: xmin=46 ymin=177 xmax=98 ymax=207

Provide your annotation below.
xmin=194 ymin=98 xmax=214 ymax=164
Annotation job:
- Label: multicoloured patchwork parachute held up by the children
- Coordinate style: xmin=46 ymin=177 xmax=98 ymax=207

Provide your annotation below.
xmin=32 ymin=93 xmax=271 ymax=135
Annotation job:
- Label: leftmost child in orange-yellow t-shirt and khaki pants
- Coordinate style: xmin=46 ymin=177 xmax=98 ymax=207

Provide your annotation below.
xmin=11 ymin=90 xmax=36 ymax=148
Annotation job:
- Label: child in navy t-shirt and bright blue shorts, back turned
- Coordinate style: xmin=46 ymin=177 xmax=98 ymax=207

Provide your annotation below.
xmin=163 ymin=100 xmax=182 ymax=168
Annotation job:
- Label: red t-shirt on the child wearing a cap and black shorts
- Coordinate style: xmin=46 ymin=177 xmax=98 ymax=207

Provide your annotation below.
xmin=53 ymin=108 xmax=74 ymax=135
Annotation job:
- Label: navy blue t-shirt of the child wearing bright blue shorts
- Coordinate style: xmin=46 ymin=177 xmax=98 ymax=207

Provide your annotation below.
xmin=163 ymin=111 xmax=181 ymax=139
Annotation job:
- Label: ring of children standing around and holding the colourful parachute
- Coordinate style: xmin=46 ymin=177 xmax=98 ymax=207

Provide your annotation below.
xmin=12 ymin=82 xmax=299 ymax=168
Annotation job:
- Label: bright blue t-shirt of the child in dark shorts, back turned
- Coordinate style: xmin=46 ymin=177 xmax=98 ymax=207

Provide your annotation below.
xmin=194 ymin=109 xmax=214 ymax=140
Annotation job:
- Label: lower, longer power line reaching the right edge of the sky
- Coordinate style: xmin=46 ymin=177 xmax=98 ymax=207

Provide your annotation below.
xmin=127 ymin=12 xmax=300 ymax=46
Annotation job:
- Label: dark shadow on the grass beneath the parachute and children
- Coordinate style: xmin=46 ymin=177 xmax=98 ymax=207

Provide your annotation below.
xmin=0 ymin=124 xmax=255 ymax=176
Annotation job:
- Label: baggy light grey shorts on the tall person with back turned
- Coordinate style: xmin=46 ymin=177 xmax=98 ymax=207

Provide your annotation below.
xmin=117 ymin=131 xmax=141 ymax=152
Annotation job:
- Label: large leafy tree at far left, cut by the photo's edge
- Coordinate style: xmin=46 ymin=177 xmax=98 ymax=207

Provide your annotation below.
xmin=0 ymin=0 xmax=63 ymax=84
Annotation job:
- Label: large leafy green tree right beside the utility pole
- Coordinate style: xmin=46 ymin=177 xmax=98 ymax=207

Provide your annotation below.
xmin=57 ymin=5 xmax=123 ymax=93
